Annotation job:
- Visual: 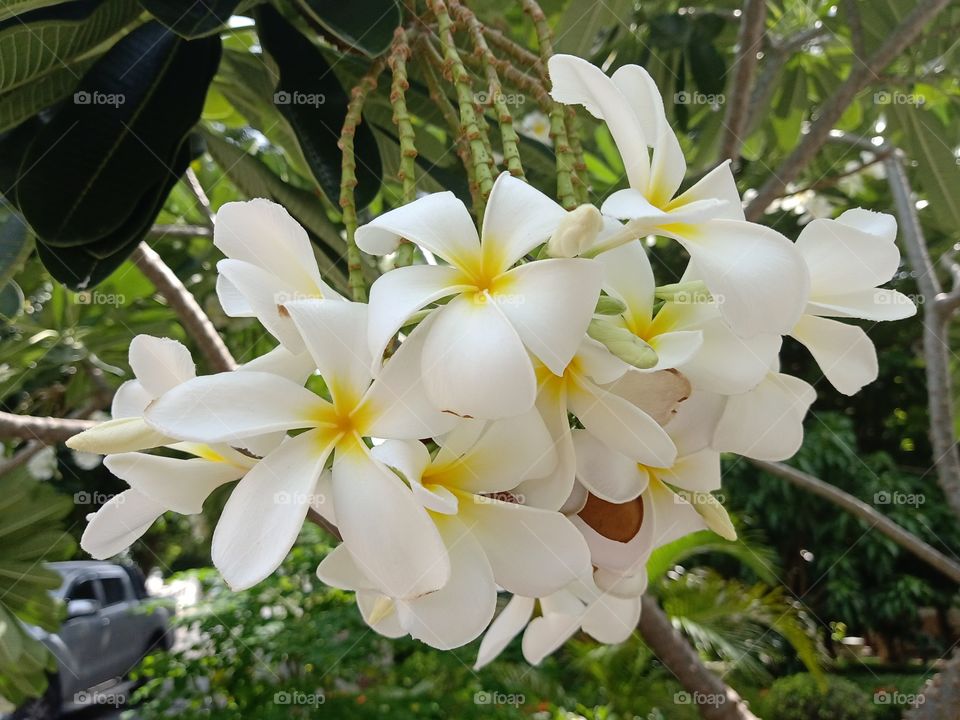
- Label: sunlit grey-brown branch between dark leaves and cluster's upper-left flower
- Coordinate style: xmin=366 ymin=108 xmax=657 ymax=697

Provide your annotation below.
xmin=131 ymin=243 xmax=237 ymax=372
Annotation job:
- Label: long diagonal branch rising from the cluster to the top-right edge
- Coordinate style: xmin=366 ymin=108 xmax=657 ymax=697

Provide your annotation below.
xmin=744 ymin=0 xmax=950 ymax=220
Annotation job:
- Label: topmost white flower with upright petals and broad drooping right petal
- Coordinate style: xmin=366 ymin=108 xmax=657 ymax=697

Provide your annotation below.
xmin=549 ymin=55 xmax=808 ymax=337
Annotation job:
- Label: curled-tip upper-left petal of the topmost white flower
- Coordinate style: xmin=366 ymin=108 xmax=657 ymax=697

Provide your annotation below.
xmin=547 ymin=55 xmax=652 ymax=189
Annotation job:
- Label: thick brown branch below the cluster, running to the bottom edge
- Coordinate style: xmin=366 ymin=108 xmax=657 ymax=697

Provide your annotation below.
xmin=638 ymin=595 xmax=757 ymax=720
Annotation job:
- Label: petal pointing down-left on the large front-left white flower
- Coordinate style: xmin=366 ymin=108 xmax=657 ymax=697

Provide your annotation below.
xmin=211 ymin=430 xmax=335 ymax=590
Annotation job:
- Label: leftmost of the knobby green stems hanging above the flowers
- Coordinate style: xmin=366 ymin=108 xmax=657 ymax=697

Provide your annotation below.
xmin=337 ymin=60 xmax=384 ymax=302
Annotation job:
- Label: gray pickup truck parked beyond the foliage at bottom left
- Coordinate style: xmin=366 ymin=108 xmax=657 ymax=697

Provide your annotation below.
xmin=10 ymin=561 xmax=172 ymax=720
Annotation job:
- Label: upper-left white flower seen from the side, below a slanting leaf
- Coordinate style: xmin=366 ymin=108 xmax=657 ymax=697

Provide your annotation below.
xmin=213 ymin=199 xmax=342 ymax=352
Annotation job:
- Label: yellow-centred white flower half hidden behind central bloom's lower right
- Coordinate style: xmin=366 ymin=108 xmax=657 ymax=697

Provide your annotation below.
xmin=520 ymin=338 xmax=677 ymax=509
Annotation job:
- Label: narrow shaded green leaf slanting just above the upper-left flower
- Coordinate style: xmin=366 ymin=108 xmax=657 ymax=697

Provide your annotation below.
xmin=204 ymin=130 xmax=347 ymax=288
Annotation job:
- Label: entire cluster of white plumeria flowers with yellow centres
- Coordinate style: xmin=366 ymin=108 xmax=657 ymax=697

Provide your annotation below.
xmin=69 ymin=55 xmax=915 ymax=665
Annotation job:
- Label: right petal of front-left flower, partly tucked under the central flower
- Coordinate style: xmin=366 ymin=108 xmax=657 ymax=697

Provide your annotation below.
xmin=358 ymin=316 xmax=460 ymax=440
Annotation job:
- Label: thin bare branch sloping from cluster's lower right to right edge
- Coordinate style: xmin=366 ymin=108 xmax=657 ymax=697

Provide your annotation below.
xmin=751 ymin=460 xmax=960 ymax=583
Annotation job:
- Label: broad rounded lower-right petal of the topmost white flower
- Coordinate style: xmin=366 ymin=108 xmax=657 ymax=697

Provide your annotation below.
xmin=662 ymin=220 xmax=809 ymax=337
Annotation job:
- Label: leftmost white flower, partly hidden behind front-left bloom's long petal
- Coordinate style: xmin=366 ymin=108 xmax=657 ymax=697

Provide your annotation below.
xmin=76 ymin=335 xmax=314 ymax=560
